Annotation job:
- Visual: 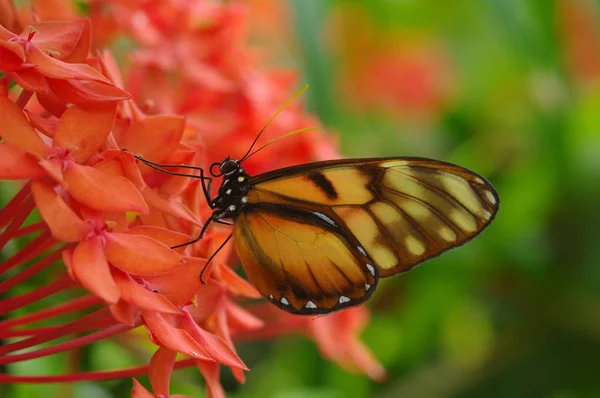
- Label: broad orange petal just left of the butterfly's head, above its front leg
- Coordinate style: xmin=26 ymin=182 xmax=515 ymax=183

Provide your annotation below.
xmin=118 ymin=115 xmax=185 ymax=162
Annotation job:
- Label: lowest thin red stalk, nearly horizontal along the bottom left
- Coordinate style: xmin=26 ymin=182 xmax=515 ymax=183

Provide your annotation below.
xmin=0 ymin=358 xmax=196 ymax=383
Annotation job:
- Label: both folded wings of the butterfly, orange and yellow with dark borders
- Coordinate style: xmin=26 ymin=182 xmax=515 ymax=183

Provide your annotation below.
xmin=234 ymin=158 xmax=499 ymax=313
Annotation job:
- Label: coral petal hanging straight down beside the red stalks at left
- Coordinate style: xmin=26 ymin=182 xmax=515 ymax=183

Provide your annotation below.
xmin=73 ymin=236 xmax=121 ymax=304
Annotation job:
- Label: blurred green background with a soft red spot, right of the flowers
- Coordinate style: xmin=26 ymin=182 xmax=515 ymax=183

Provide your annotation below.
xmin=4 ymin=0 xmax=600 ymax=398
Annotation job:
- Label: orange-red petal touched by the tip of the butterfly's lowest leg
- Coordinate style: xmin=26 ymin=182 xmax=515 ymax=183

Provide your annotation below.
xmin=145 ymin=256 xmax=210 ymax=305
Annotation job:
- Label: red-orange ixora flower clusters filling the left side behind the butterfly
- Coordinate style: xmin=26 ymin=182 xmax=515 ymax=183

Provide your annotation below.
xmin=0 ymin=0 xmax=384 ymax=397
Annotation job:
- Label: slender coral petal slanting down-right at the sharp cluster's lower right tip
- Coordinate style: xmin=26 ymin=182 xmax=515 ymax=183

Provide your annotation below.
xmin=179 ymin=313 xmax=249 ymax=370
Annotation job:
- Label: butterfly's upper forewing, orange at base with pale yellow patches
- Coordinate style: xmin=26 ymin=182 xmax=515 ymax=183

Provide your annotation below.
xmin=249 ymin=158 xmax=499 ymax=280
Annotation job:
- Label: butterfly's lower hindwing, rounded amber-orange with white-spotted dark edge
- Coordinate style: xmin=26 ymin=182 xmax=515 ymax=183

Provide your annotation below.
xmin=233 ymin=193 xmax=377 ymax=315
